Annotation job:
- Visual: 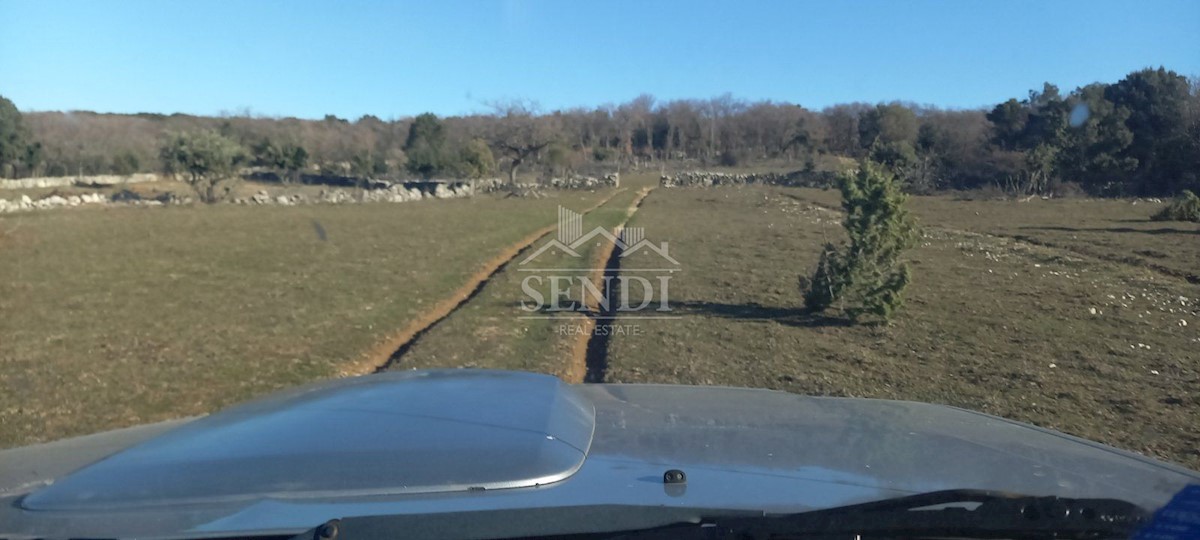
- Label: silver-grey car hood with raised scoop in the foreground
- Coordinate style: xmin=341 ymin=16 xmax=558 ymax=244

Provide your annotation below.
xmin=0 ymin=370 xmax=1200 ymax=538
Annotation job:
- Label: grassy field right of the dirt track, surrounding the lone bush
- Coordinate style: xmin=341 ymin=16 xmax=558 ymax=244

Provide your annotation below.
xmin=607 ymin=187 xmax=1200 ymax=468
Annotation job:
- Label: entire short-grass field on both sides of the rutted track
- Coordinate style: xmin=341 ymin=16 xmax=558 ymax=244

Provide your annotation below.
xmin=0 ymin=173 xmax=1200 ymax=468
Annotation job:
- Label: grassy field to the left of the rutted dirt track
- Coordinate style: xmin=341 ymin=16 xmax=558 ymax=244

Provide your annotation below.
xmin=0 ymin=192 xmax=607 ymax=446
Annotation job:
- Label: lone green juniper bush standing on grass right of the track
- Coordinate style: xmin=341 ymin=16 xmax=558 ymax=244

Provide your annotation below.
xmin=800 ymin=161 xmax=917 ymax=322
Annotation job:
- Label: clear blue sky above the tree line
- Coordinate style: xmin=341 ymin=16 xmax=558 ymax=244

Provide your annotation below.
xmin=0 ymin=0 xmax=1200 ymax=119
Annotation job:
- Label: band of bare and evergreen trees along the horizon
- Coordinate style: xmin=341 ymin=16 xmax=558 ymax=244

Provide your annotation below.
xmin=0 ymin=68 xmax=1200 ymax=196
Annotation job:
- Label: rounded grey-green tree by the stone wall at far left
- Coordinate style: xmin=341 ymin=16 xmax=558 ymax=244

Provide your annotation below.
xmin=158 ymin=130 xmax=246 ymax=203
